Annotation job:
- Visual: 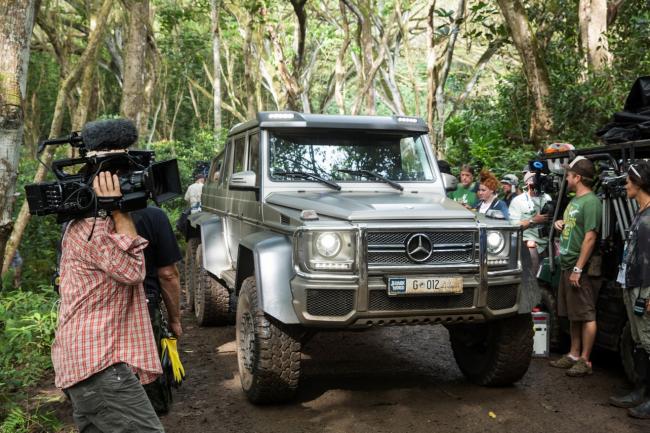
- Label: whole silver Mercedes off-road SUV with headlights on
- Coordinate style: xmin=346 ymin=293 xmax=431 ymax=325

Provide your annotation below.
xmin=187 ymin=112 xmax=534 ymax=403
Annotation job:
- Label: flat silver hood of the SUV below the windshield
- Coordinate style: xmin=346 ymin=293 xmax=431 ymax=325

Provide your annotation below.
xmin=266 ymin=191 xmax=475 ymax=221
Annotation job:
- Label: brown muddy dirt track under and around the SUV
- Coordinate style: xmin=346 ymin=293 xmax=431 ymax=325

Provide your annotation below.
xmin=53 ymin=313 xmax=650 ymax=433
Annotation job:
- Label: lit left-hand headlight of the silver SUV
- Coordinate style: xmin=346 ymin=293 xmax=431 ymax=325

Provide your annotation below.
xmin=296 ymin=230 xmax=357 ymax=272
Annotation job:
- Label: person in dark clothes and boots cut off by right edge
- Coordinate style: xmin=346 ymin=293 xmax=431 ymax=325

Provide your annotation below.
xmin=609 ymin=161 xmax=650 ymax=419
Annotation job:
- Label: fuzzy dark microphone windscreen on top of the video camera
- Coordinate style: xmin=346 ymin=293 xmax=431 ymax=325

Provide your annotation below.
xmin=81 ymin=119 xmax=138 ymax=151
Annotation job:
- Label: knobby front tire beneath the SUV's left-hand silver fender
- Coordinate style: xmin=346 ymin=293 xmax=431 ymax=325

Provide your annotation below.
xmin=236 ymin=277 xmax=301 ymax=404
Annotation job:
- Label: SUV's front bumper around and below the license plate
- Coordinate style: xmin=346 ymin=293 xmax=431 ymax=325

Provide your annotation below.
xmin=291 ymin=274 xmax=521 ymax=328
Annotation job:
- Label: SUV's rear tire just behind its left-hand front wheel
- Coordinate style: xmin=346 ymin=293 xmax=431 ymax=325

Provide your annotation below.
xmin=194 ymin=249 xmax=235 ymax=326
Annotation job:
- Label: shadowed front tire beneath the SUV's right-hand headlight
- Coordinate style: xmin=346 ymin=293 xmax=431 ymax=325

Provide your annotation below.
xmin=449 ymin=314 xmax=533 ymax=386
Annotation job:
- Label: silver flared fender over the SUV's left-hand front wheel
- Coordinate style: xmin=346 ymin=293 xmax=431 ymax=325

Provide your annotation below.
xmin=237 ymin=232 xmax=300 ymax=324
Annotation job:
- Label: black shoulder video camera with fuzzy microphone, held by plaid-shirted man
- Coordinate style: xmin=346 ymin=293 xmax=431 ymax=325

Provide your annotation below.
xmin=25 ymin=119 xmax=181 ymax=222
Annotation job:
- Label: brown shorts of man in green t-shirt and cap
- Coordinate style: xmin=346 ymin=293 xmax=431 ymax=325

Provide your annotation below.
xmin=557 ymin=270 xmax=598 ymax=322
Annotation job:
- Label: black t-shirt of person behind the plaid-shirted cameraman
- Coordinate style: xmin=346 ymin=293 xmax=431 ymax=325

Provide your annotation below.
xmin=131 ymin=207 xmax=182 ymax=302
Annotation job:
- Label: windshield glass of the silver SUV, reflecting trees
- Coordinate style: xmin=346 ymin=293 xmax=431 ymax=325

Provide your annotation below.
xmin=269 ymin=130 xmax=434 ymax=182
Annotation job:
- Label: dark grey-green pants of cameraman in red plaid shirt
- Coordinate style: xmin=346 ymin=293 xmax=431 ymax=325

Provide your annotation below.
xmin=65 ymin=363 xmax=165 ymax=433
